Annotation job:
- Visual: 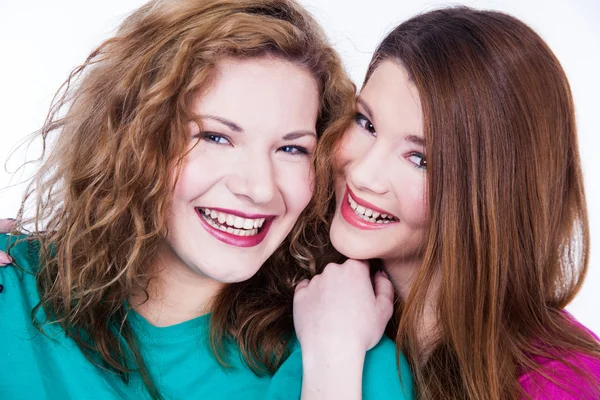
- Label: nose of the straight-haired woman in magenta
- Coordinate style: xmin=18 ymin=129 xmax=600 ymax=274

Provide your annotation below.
xmin=347 ymin=143 xmax=389 ymax=195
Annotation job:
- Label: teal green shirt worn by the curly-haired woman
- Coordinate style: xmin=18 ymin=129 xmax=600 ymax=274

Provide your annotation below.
xmin=0 ymin=235 xmax=413 ymax=400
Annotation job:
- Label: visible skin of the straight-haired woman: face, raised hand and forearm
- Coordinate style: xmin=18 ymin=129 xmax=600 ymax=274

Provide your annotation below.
xmin=294 ymin=62 xmax=433 ymax=398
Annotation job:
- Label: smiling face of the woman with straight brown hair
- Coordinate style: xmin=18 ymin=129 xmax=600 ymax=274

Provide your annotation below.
xmin=330 ymin=61 xmax=429 ymax=263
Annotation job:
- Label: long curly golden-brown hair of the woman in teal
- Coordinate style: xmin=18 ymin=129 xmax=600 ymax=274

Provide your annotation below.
xmin=7 ymin=0 xmax=355 ymax=398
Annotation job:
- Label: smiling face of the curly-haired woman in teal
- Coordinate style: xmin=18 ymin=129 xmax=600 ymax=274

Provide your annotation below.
xmin=162 ymin=58 xmax=319 ymax=282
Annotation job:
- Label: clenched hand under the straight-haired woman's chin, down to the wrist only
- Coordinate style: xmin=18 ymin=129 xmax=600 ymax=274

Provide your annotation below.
xmin=294 ymin=260 xmax=394 ymax=353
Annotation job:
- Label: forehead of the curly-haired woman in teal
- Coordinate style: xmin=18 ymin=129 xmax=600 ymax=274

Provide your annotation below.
xmin=193 ymin=58 xmax=319 ymax=130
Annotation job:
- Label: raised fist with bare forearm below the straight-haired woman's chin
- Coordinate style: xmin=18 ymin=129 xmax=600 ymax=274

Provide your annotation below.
xmin=294 ymin=260 xmax=394 ymax=400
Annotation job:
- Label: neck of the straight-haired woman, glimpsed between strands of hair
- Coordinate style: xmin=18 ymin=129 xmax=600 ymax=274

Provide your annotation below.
xmin=382 ymin=258 xmax=440 ymax=353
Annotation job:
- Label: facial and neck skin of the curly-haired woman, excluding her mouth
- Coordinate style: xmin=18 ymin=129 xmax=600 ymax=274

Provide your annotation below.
xmin=112 ymin=58 xmax=318 ymax=326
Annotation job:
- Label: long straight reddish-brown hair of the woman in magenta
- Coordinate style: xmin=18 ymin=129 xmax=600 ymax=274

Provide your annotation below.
xmin=318 ymin=7 xmax=600 ymax=400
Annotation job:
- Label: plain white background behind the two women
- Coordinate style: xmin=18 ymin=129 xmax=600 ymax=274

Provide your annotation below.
xmin=0 ymin=0 xmax=600 ymax=333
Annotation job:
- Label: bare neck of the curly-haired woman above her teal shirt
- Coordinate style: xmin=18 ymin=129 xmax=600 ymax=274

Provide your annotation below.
xmin=130 ymin=244 xmax=224 ymax=327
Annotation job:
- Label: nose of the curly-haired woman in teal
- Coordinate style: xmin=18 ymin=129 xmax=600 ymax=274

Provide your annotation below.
xmin=227 ymin=154 xmax=277 ymax=204
